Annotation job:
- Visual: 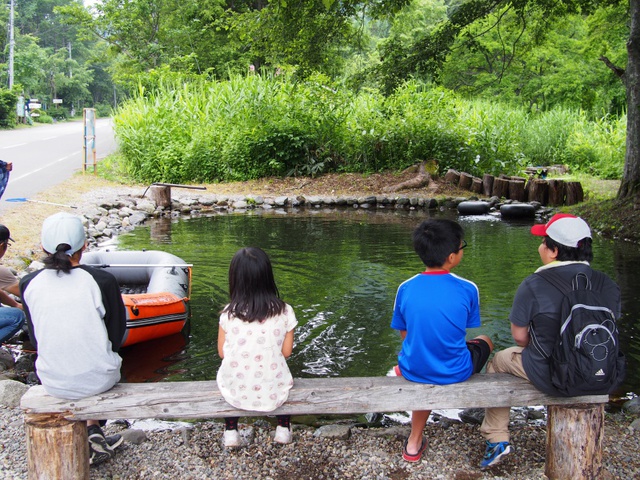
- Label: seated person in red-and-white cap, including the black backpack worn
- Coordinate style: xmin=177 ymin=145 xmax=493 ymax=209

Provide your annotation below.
xmin=480 ymin=213 xmax=625 ymax=468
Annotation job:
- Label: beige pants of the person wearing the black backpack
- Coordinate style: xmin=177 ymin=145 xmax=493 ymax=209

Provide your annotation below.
xmin=480 ymin=347 xmax=529 ymax=443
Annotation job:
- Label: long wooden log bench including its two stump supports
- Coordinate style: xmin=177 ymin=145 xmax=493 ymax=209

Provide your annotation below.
xmin=21 ymin=374 xmax=609 ymax=479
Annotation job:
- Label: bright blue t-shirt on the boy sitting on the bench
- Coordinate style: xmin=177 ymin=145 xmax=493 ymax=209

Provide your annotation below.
xmin=391 ymin=270 xmax=480 ymax=385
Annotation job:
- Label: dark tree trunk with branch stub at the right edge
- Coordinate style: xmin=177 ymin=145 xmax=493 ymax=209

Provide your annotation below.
xmin=601 ymin=0 xmax=640 ymax=200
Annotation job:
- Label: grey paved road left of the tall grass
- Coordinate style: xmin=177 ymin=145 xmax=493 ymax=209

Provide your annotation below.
xmin=0 ymin=118 xmax=116 ymax=211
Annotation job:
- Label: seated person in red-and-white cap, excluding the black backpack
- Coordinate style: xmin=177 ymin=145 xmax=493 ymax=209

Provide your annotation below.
xmin=480 ymin=213 xmax=621 ymax=468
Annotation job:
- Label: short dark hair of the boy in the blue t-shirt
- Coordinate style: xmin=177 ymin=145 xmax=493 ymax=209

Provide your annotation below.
xmin=413 ymin=218 xmax=464 ymax=268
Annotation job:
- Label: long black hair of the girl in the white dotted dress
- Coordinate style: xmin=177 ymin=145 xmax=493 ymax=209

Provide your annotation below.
xmin=223 ymin=247 xmax=286 ymax=322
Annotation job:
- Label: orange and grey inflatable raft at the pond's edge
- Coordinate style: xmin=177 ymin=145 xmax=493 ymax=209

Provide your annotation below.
xmin=81 ymin=250 xmax=191 ymax=347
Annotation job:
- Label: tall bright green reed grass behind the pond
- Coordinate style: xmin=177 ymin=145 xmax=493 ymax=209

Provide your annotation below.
xmin=114 ymin=75 xmax=626 ymax=182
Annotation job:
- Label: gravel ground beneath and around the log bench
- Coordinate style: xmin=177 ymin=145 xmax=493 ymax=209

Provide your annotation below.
xmin=0 ymin=407 xmax=640 ymax=480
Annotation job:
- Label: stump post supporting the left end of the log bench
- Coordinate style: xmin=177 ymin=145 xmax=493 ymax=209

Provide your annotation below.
xmin=25 ymin=414 xmax=89 ymax=480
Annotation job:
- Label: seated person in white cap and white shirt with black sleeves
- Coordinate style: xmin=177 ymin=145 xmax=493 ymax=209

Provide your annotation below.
xmin=20 ymin=212 xmax=126 ymax=465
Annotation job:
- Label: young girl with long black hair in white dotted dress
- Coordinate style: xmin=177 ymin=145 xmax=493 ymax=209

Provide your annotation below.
xmin=216 ymin=247 xmax=298 ymax=447
